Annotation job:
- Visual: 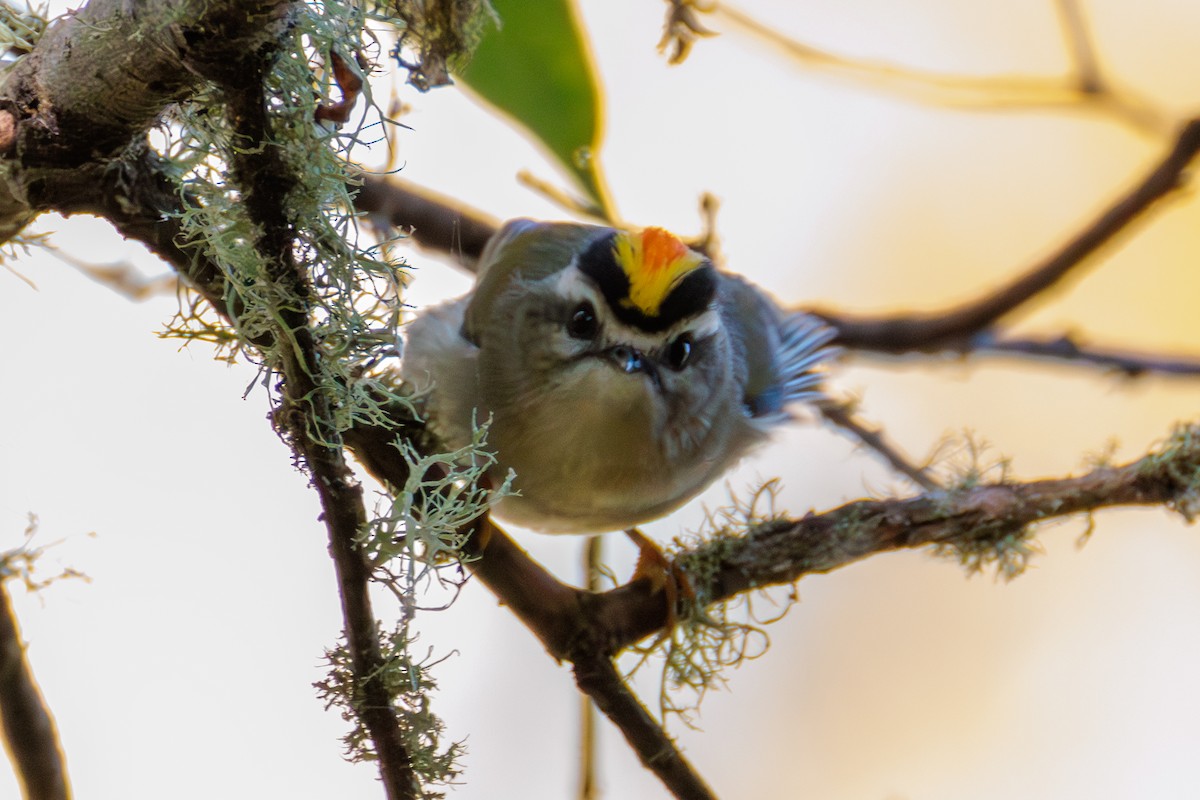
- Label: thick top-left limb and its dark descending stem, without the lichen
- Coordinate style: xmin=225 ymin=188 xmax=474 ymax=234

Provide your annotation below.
xmin=0 ymin=0 xmax=427 ymax=798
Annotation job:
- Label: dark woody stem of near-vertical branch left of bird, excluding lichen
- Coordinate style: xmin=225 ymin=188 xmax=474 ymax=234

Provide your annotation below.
xmin=226 ymin=61 xmax=421 ymax=800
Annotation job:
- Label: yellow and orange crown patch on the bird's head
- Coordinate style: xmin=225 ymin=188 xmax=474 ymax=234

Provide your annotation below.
xmin=614 ymin=228 xmax=704 ymax=317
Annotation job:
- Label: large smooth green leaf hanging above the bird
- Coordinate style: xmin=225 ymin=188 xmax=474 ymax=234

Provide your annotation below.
xmin=456 ymin=0 xmax=610 ymax=216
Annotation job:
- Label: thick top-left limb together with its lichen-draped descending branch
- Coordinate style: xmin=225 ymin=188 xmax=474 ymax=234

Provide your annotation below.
xmin=0 ymin=9 xmax=475 ymax=798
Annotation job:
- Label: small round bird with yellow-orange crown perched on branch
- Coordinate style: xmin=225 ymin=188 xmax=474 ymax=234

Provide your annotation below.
xmin=402 ymin=219 xmax=834 ymax=533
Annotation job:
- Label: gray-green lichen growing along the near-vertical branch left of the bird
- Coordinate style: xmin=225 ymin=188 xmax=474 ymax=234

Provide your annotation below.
xmin=155 ymin=1 xmax=504 ymax=796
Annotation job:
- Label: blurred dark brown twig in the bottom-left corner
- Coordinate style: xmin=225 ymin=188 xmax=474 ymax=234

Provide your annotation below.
xmin=0 ymin=581 xmax=71 ymax=800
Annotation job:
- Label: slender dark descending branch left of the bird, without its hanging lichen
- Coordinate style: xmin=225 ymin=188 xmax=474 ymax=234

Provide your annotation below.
xmin=211 ymin=21 xmax=436 ymax=800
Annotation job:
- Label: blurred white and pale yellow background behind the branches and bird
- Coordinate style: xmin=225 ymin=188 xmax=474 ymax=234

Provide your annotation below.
xmin=0 ymin=0 xmax=1200 ymax=800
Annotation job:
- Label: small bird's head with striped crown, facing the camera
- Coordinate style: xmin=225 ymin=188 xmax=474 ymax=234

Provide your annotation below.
xmin=479 ymin=225 xmax=740 ymax=462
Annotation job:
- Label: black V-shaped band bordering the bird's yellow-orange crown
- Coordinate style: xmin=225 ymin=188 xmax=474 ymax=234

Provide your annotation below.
xmin=578 ymin=231 xmax=716 ymax=333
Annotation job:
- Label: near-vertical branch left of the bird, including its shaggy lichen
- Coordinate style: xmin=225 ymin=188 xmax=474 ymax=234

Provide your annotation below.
xmin=178 ymin=4 xmax=496 ymax=798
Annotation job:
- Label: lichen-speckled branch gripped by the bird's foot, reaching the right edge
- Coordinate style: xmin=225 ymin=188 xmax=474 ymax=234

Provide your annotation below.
xmin=369 ymin=425 xmax=1200 ymax=660
